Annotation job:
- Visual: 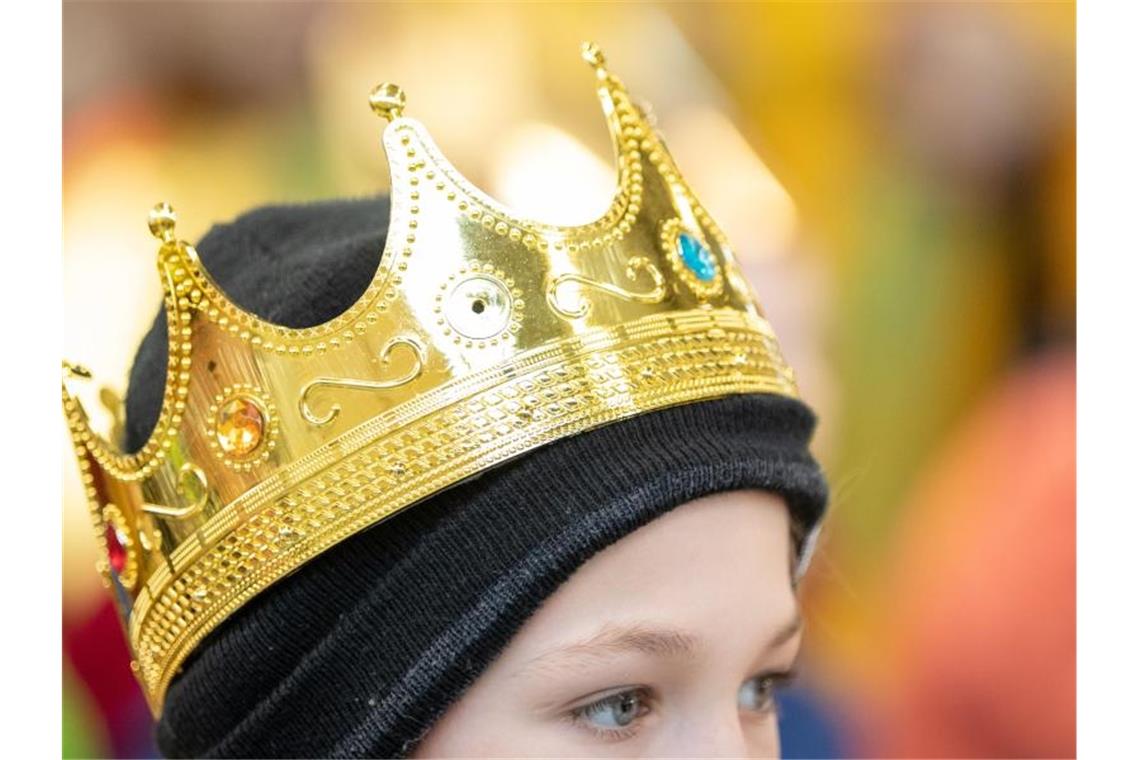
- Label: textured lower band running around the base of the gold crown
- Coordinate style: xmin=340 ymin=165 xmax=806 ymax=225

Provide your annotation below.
xmin=122 ymin=311 xmax=795 ymax=701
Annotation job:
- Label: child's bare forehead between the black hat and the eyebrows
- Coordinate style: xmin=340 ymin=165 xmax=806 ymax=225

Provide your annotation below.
xmin=514 ymin=491 xmax=796 ymax=656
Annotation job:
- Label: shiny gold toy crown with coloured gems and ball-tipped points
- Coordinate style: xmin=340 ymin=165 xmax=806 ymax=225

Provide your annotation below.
xmin=63 ymin=43 xmax=797 ymax=716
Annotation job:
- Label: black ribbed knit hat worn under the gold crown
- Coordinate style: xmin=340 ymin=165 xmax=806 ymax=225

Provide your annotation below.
xmin=127 ymin=198 xmax=827 ymax=757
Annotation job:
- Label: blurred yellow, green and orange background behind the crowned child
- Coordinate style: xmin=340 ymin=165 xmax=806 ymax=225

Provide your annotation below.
xmin=60 ymin=1 xmax=1076 ymax=757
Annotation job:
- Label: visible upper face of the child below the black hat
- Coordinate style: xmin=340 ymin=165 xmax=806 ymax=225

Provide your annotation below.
xmin=417 ymin=491 xmax=801 ymax=757
